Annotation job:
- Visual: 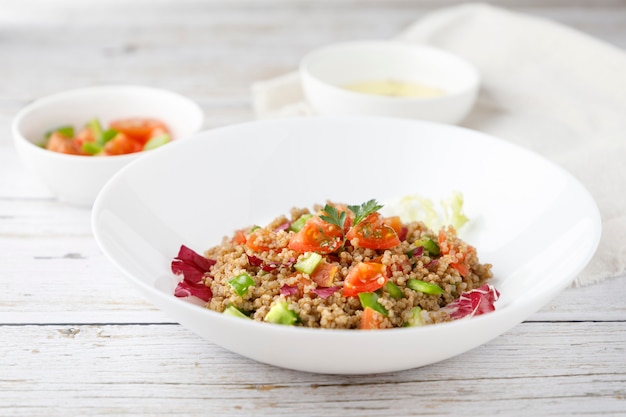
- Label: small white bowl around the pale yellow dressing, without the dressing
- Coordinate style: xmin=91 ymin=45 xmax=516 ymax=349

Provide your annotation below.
xmin=300 ymin=41 xmax=480 ymax=124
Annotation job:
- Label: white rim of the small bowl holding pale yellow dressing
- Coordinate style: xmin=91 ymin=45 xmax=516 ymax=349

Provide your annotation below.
xmin=298 ymin=40 xmax=481 ymax=103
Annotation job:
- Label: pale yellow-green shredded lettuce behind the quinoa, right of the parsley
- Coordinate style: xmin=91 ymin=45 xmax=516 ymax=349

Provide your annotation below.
xmin=387 ymin=191 xmax=469 ymax=231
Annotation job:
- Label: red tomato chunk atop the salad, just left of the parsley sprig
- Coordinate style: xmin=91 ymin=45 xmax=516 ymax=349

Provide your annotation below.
xmin=288 ymin=216 xmax=343 ymax=254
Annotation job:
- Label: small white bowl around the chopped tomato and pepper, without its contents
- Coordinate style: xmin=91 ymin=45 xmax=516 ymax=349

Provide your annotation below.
xmin=11 ymin=85 xmax=204 ymax=207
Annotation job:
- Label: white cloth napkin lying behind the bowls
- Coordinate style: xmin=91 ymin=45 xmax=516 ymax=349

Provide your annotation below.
xmin=252 ymin=4 xmax=626 ymax=286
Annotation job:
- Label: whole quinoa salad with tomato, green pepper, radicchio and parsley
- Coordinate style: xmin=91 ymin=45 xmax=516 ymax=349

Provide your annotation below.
xmin=171 ymin=200 xmax=499 ymax=329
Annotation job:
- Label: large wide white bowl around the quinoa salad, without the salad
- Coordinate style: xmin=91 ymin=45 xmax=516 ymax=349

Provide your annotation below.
xmin=92 ymin=118 xmax=600 ymax=374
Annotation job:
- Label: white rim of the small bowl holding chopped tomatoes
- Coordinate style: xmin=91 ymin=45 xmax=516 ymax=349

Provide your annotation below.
xmin=11 ymin=84 xmax=204 ymax=159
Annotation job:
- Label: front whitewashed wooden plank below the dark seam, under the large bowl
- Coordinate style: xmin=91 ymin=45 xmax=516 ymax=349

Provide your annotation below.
xmin=0 ymin=322 xmax=626 ymax=417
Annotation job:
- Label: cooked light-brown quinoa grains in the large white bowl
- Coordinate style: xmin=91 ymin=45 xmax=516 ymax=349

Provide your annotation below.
xmin=176 ymin=200 xmax=492 ymax=329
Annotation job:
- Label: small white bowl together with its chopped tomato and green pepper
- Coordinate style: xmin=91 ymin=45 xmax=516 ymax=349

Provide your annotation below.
xmin=11 ymin=85 xmax=204 ymax=207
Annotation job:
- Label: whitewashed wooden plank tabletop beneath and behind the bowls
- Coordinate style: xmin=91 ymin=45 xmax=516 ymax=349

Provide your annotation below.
xmin=0 ymin=0 xmax=626 ymax=416
